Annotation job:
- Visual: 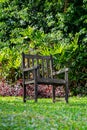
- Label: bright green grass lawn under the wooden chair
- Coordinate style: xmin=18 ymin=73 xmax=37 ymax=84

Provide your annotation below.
xmin=0 ymin=97 xmax=87 ymax=130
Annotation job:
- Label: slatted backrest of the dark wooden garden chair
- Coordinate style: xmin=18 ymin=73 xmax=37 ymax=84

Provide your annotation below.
xmin=22 ymin=53 xmax=53 ymax=78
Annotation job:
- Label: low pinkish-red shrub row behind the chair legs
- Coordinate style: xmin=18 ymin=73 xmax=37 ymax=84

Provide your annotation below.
xmin=0 ymin=80 xmax=64 ymax=98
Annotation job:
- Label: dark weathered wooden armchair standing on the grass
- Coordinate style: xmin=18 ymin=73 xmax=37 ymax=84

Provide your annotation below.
xmin=22 ymin=53 xmax=68 ymax=103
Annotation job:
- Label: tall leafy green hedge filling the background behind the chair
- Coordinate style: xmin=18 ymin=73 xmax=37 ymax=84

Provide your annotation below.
xmin=0 ymin=0 xmax=87 ymax=95
